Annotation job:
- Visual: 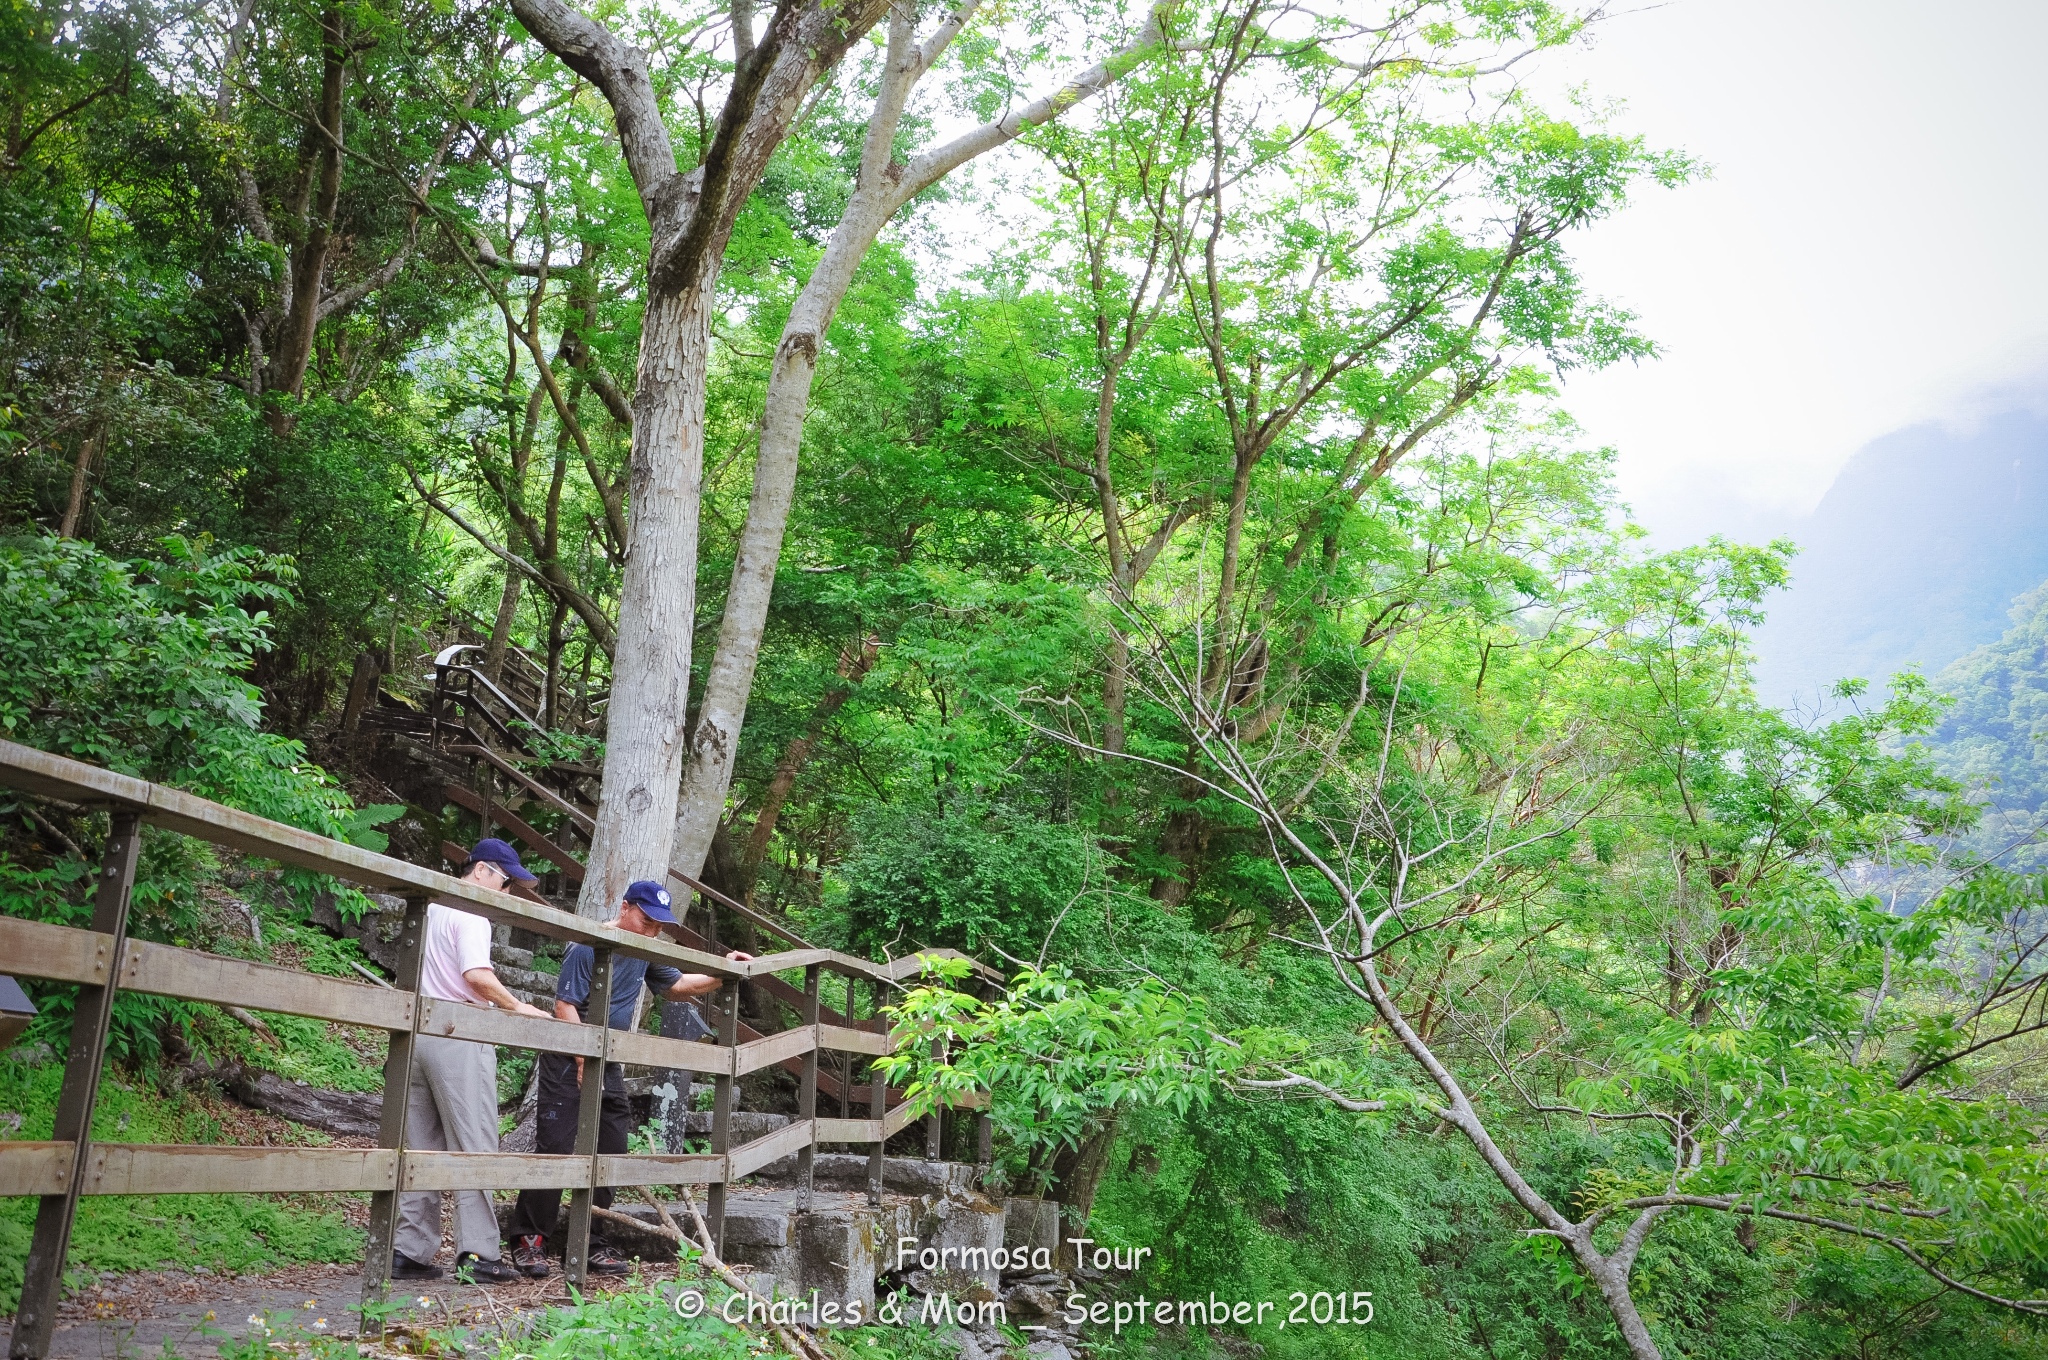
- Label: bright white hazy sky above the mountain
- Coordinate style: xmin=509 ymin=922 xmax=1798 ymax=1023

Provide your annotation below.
xmin=1538 ymin=0 xmax=2048 ymax=541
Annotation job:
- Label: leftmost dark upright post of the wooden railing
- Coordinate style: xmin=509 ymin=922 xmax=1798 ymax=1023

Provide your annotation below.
xmin=8 ymin=807 xmax=141 ymax=1360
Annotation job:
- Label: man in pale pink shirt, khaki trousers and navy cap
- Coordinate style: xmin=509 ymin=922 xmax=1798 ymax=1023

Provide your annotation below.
xmin=391 ymin=840 xmax=553 ymax=1284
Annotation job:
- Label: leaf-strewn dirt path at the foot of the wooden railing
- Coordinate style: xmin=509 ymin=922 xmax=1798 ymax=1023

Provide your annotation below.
xmin=0 ymin=1264 xmax=676 ymax=1360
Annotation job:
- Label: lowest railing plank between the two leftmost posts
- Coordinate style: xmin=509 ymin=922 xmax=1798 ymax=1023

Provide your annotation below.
xmin=84 ymin=1143 xmax=397 ymax=1194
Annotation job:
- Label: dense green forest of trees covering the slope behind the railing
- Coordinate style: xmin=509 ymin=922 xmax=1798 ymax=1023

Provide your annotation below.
xmin=0 ymin=0 xmax=2048 ymax=1360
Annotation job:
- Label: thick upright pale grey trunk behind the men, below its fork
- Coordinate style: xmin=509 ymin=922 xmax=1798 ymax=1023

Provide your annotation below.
xmin=575 ymin=280 xmax=717 ymax=920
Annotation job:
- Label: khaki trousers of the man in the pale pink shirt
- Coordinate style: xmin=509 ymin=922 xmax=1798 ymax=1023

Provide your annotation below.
xmin=391 ymin=1034 xmax=500 ymax=1262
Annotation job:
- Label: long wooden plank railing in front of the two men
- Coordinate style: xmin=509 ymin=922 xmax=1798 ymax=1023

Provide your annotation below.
xmin=0 ymin=741 xmax=989 ymax=1360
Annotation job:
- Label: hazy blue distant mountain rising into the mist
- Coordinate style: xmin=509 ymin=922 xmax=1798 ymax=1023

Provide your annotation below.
xmin=1757 ymin=412 xmax=2048 ymax=705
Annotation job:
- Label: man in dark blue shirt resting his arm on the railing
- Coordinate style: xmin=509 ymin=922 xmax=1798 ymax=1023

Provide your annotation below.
xmin=512 ymin=879 xmax=752 ymax=1278
